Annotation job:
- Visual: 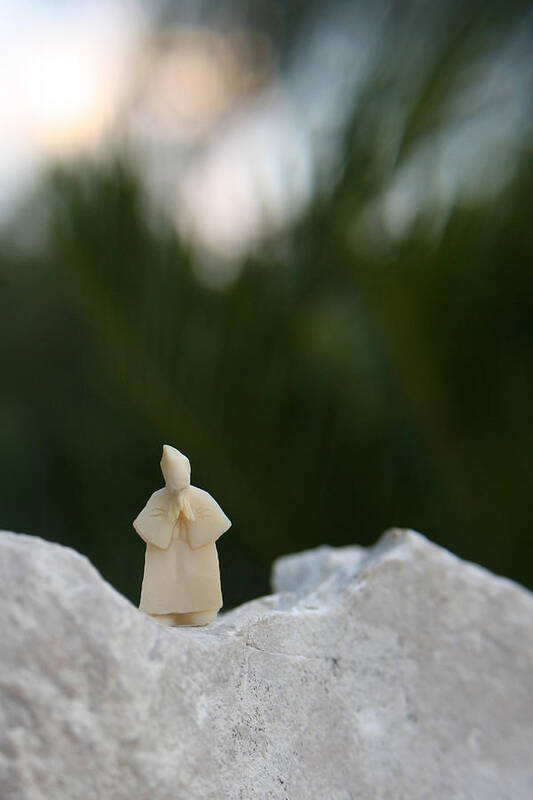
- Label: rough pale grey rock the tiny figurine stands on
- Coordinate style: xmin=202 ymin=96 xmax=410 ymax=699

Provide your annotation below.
xmin=0 ymin=531 xmax=533 ymax=800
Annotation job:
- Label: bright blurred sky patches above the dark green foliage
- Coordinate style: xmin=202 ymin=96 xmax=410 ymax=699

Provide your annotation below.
xmin=0 ymin=0 xmax=533 ymax=270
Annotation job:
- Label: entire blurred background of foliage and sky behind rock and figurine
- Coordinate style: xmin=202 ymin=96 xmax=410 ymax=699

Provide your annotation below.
xmin=0 ymin=0 xmax=533 ymax=607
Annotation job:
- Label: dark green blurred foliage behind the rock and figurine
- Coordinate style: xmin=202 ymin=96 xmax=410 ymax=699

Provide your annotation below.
xmin=0 ymin=0 xmax=533 ymax=605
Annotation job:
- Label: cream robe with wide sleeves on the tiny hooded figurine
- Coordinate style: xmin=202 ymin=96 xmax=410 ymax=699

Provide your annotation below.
xmin=133 ymin=486 xmax=231 ymax=614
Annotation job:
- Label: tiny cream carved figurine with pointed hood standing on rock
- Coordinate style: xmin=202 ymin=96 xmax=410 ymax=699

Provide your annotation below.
xmin=133 ymin=444 xmax=231 ymax=625
